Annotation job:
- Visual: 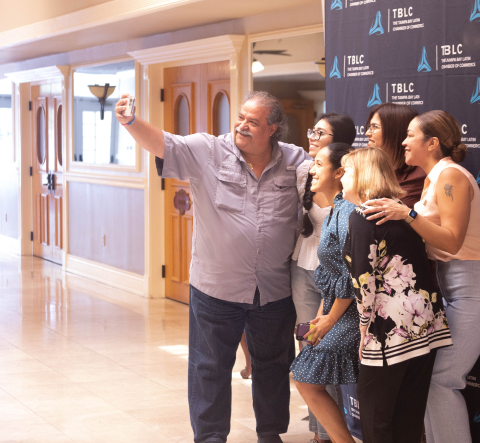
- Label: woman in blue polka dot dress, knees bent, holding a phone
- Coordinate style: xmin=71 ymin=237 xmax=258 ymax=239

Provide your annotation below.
xmin=290 ymin=143 xmax=360 ymax=443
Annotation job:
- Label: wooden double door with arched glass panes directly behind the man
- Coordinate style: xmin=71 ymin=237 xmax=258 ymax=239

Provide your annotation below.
xmin=164 ymin=61 xmax=230 ymax=303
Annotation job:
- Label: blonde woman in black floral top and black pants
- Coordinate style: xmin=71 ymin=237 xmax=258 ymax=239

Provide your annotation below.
xmin=342 ymin=148 xmax=452 ymax=443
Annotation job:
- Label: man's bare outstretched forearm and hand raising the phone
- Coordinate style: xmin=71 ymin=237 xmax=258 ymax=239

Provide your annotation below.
xmin=115 ymin=94 xmax=165 ymax=158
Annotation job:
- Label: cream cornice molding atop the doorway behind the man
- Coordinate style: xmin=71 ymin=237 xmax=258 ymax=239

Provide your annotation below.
xmin=128 ymin=35 xmax=245 ymax=65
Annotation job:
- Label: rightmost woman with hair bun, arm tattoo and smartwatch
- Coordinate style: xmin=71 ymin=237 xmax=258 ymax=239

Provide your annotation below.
xmin=364 ymin=111 xmax=480 ymax=443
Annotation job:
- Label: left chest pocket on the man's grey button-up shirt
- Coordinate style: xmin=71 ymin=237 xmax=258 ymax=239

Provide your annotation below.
xmin=215 ymin=169 xmax=247 ymax=214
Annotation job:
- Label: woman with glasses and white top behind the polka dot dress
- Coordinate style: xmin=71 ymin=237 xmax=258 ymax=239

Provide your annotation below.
xmin=291 ymin=113 xmax=356 ymax=442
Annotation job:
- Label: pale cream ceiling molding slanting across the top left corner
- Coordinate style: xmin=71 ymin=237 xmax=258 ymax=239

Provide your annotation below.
xmin=0 ymin=0 xmax=200 ymax=49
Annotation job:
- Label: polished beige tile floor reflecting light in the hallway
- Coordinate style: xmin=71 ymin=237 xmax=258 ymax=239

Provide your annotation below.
xmin=0 ymin=252 xmax=322 ymax=443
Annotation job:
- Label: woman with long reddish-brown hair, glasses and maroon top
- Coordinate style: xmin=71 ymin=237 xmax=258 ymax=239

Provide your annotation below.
xmin=365 ymin=103 xmax=425 ymax=208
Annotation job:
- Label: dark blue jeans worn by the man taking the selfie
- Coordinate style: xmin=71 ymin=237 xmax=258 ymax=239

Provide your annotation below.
xmin=188 ymin=285 xmax=295 ymax=443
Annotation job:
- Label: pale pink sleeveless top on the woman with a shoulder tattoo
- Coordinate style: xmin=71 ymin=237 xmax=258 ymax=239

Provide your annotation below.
xmin=414 ymin=157 xmax=480 ymax=261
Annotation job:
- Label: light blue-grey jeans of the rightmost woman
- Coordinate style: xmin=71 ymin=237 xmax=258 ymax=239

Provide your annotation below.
xmin=425 ymin=260 xmax=480 ymax=443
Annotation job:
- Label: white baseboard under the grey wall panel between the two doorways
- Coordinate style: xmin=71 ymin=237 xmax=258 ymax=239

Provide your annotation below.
xmin=65 ymin=254 xmax=148 ymax=298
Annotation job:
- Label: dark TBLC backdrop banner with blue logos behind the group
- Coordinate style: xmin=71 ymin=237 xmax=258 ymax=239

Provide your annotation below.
xmin=325 ymin=0 xmax=480 ymax=183
